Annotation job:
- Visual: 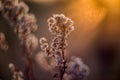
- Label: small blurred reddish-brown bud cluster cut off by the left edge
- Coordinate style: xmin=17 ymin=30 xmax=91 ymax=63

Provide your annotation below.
xmin=0 ymin=32 xmax=8 ymax=50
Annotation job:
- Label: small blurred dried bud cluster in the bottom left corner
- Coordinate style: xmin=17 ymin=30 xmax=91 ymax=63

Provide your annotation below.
xmin=8 ymin=63 xmax=24 ymax=80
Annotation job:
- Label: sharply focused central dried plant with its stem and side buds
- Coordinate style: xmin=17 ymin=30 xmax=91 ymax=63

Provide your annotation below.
xmin=40 ymin=14 xmax=74 ymax=80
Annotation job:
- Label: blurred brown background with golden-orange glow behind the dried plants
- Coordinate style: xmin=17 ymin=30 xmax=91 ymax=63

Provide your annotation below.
xmin=0 ymin=0 xmax=120 ymax=80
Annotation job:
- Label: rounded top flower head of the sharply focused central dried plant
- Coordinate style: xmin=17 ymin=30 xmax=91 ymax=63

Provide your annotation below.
xmin=48 ymin=14 xmax=74 ymax=35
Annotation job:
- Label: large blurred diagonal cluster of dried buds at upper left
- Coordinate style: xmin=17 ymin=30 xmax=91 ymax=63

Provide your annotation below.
xmin=0 ymin=0 xmax=38 ymax=52
